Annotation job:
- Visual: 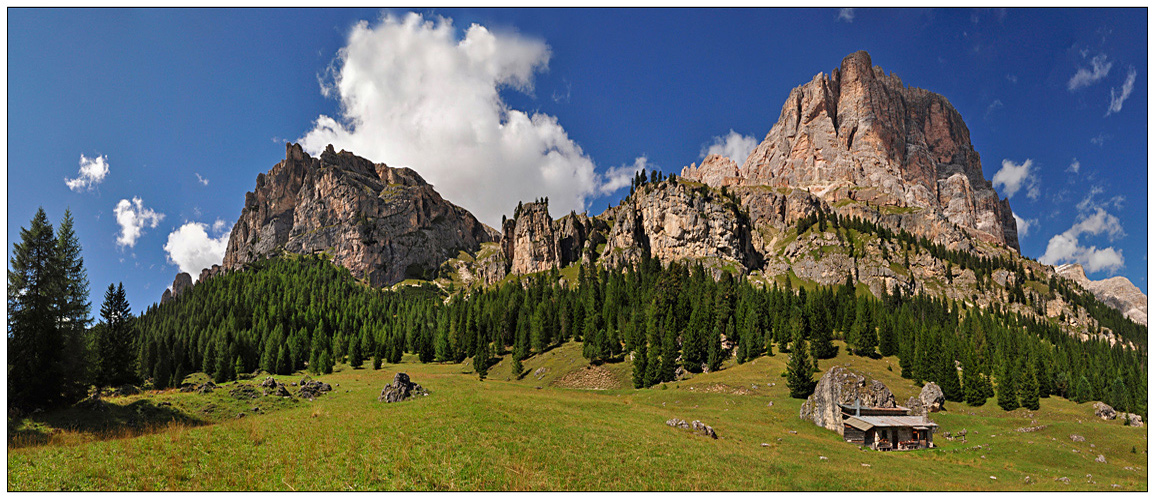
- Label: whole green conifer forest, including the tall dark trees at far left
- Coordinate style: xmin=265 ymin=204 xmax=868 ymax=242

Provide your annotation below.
xmin=8 ymin=206 xmax=1147 ymax=416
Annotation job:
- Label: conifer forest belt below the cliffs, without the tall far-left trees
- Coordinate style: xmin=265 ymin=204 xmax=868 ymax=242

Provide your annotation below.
xmin=131 ymin=249 xmax=1147 ymax=414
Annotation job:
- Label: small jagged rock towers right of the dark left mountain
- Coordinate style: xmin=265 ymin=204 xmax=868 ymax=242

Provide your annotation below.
xmin=501 ymin=201 xmax=609 ymax=274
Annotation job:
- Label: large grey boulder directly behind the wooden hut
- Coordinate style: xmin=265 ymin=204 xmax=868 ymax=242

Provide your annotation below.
xmin=798 ymin=366 xmax=895 ymax=434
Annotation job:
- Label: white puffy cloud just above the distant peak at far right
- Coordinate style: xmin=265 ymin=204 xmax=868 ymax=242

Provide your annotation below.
xmin=1038 ymin=208 xmax=1124 ymax=273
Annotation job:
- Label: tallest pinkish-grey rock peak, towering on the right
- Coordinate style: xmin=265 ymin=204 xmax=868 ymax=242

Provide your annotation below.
xmin=683 ymin=52 xmax=1019 ymax=251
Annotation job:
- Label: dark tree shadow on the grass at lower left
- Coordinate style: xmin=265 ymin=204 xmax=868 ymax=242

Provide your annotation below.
xmin=8 ymin=399 xmax=208 ymax=449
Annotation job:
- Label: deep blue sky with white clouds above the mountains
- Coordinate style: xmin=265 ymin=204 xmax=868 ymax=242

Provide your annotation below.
xmin=8 ymin=9 xmax=1148 ymax=312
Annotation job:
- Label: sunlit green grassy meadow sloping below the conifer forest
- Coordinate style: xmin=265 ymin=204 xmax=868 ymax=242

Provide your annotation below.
xmin=8 ymin=343 xmax=1147 ymax=491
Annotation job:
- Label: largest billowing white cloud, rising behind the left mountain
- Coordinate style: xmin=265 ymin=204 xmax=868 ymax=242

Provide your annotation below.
xmin=293 ymin=13 xmax=628 ymax=226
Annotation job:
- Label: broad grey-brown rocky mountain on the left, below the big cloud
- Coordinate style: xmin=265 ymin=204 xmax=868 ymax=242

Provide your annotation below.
xmin=223 ymin=144 xmax=498 ymax=286
